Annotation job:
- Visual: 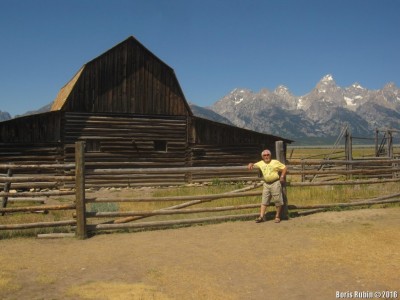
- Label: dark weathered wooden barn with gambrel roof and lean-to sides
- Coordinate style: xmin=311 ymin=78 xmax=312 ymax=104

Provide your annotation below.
xmin=0 ymin=37 xmax=291 ymax=185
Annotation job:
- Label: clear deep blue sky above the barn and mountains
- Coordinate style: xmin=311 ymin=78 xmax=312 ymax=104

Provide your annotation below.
xmin=0 ymin=0 xmax=400 ymax=116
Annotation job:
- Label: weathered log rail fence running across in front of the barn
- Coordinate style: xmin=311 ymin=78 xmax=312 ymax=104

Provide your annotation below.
xmin=0 ymin=142 xmax=400 ymax=239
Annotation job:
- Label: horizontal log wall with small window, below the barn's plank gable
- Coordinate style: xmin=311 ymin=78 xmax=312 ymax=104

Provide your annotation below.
xmin=64 ymin=113 xmax=188 ymax=186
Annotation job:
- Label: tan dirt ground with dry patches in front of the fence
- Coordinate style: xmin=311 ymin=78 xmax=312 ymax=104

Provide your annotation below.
xmin=0 ymin=207 xmax=400 ymax=300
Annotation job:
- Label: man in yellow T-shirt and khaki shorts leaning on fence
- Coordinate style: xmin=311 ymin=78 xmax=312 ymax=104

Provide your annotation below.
xmin=247 ymin=149 xmax=287 ymax=223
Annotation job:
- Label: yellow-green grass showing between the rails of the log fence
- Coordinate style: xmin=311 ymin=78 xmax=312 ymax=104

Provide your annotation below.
xmin=0 ymin=182 xmax=400 ymax=239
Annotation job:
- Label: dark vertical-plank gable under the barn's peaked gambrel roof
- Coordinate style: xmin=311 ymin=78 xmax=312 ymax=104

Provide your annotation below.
xmin=62 ymin=38 xmax=190 ymax=116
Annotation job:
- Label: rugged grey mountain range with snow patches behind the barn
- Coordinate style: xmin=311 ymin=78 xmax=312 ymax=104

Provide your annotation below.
xmin=0 ymin=74 xmax=400 ymax=144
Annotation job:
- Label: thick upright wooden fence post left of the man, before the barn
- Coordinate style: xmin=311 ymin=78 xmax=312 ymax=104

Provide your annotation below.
xmin=75 ymin=142 xmax=87 ymax=240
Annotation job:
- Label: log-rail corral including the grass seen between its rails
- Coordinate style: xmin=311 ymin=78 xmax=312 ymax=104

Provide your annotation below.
xmin=0 ymin=143 xmax=400 ymax=238
